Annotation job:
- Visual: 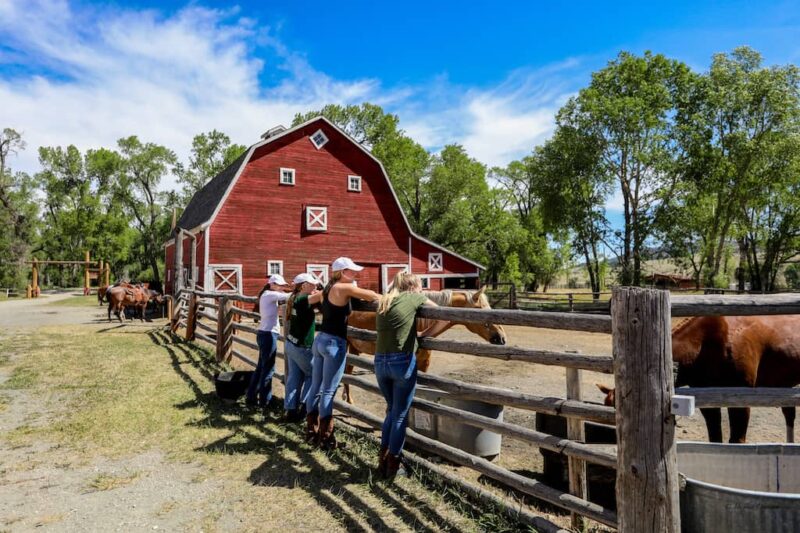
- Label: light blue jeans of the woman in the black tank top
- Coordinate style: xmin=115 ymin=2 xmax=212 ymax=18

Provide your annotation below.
xmin=306 ymin=332 xmax=347 ymax=418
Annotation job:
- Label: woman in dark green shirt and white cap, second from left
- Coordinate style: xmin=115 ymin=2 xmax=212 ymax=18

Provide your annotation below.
xmin=283 ymin=273 xmax=319 ymax=422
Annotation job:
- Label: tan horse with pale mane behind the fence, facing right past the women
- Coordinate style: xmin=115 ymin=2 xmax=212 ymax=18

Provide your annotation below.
xmin=342 ymin=287 xmax=506 ymax=404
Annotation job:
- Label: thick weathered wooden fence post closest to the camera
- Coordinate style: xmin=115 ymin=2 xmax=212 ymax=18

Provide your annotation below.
xmin=611 ymin=287 xmax=681 ymax=533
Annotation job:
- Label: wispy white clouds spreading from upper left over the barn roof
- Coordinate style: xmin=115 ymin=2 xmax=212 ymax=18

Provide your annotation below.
xmin=0 ymin=0 xmax=578 ymax=187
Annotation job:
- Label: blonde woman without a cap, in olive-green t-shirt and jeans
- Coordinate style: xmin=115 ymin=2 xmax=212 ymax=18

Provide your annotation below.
xmin=375 ymin=272 xmax=448 ymax=478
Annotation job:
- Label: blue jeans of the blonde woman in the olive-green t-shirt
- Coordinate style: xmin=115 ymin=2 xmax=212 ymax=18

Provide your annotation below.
xmin=375 ymin=352 xmax=417 ymax=455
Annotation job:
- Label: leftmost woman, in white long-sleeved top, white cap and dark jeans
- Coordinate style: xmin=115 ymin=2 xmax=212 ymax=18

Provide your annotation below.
xmin=246 ymin=274 xmax=289 ymax=414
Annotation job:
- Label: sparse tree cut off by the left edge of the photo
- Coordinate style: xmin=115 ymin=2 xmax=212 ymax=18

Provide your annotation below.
xmin=0 ymin=128 xmax=38 ymax=287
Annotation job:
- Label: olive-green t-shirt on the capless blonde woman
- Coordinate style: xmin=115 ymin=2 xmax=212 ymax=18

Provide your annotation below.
xmin=375 ymin=292 xmax=428 ymax=353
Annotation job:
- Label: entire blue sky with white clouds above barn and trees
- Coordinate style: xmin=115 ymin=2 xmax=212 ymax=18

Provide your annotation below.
xmin=0 ymin=0 xmax=800 ymax=198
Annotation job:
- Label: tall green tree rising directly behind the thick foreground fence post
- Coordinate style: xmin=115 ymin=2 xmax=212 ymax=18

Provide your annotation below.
xmin=558 ymin=52 xmax=689 ymax=285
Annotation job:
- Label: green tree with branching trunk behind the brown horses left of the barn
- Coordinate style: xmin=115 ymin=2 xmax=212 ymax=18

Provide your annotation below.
xmin=114 ymin=136 xmax=177 ymax=283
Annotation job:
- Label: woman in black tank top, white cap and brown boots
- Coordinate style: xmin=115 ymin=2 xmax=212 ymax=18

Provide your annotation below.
xmin=306 ymin=257 xmax=380 ymax=450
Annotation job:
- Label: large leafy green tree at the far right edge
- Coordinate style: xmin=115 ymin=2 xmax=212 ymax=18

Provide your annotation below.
xmin=676 ymin=47 xmax=800 ymax=284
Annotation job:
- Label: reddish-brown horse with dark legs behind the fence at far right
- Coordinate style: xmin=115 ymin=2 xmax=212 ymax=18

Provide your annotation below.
xmin=598 ymin=315 xmax=800 ymax=443
